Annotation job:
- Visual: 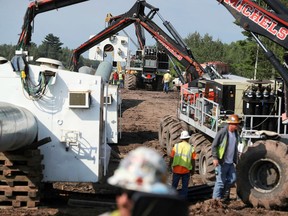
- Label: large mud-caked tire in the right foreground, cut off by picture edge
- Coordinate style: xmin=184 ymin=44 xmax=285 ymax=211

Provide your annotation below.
xmin=237 ymin=140 xmax=288 ymax=209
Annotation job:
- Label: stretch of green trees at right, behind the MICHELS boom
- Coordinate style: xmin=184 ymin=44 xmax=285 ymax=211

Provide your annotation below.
xmin=185 ymin=31 xmax=285 ymax=79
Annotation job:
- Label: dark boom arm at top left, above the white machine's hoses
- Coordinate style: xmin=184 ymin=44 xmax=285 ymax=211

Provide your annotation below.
xmin=17 ymin=0 xmax=88 ymax=49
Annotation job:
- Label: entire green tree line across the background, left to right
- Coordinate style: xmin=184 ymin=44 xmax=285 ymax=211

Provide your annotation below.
xmin=0 ymin=32 xmax=285 ymax=79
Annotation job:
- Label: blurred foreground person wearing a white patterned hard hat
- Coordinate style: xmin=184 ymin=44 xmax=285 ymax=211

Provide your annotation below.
xmin=102 ymin=146 xmax=177 ymax=216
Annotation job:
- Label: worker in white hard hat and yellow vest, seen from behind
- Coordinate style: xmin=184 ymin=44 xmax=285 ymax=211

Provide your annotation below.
xmin=169 ymin=130 xmax=196 ymax=198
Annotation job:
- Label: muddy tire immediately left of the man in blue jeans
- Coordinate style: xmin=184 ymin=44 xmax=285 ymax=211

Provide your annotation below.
xmin=199 ymin=142 xmax=216 ymax=183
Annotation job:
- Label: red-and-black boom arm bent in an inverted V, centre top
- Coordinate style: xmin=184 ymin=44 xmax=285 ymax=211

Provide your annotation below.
xmin=72 ymin=0 xmax=208 ymax=81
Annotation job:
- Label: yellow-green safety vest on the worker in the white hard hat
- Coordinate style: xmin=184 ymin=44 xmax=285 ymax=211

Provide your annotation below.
xmin=172 ymin=142 xmax=194 ymax=170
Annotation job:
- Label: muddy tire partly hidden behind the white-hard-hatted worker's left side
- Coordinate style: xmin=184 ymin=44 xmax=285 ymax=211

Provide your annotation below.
xmin=166 ymin=121 xmax=188 ymax=155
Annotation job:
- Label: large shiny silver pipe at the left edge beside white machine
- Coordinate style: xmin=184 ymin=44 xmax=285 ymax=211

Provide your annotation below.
xmin=0 ymin=102 xmax=38 ymax=152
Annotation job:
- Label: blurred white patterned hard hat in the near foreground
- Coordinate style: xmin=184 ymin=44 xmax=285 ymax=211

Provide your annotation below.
xmin=108 ymin=147 xmax=175 ymax=194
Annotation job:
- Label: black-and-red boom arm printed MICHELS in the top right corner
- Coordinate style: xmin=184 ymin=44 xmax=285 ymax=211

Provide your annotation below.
xmin=217 ymin=0 xmax=288 ymax=85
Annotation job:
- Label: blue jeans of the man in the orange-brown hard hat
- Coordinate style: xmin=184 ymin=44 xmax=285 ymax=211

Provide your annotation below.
xmin=213 ymin=163 xmax=236 ymax=199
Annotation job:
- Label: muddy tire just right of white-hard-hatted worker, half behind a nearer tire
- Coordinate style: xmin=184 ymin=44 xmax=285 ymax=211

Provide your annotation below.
xmin=189 ymin=133 xmax=211 ymax=173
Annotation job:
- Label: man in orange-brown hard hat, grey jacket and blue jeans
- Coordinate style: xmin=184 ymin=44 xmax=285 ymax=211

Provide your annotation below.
xmin=212 ymin=114 xmax=240 ymax=202
